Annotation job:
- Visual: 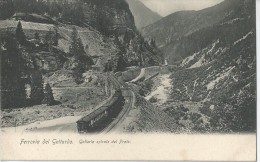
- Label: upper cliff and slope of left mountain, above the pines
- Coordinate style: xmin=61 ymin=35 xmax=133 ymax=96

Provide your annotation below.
xmin=1 ymin=0 xmax=165 ymax=70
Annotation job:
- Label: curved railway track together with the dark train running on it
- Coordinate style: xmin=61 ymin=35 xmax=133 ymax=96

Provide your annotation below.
xmin=77 ymin=74 xmax=135 ymax=133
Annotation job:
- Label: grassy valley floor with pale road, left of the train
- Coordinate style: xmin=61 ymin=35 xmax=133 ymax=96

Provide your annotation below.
xmin=1 ymin=87 xmax=108 ymax=131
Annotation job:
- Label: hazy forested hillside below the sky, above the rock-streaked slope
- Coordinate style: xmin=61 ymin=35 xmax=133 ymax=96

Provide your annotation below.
xmin=142 ymin=0 xmax=254 ymax=63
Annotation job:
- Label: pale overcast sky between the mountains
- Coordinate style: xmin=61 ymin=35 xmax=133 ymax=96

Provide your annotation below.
xmin=140 ymin=0 xmax=223 ymax=16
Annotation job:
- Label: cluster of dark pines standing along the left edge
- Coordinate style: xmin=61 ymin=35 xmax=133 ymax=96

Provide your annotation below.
xmin=1 ymin=22 xmax=55 ymax=108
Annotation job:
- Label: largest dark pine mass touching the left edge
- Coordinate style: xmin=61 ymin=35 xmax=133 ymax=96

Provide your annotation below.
xmin=0 ymin=35 xmax=26 ymax=108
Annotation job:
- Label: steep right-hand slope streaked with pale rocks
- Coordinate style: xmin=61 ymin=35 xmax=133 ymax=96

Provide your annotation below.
xmin=167 ymin=0 xmax=256 ymax=132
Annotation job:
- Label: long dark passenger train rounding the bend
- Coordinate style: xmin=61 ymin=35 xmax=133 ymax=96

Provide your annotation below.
xmin=77 ymin=74 xmax=132 ymax=133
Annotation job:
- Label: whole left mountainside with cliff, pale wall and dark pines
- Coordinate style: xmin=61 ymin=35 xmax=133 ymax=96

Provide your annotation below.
xmin=0 ymin=0 xmax=163 ymax=108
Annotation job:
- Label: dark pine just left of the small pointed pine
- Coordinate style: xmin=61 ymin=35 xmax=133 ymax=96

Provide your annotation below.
xmin=30 ymin=71 xmax=44 ymax=104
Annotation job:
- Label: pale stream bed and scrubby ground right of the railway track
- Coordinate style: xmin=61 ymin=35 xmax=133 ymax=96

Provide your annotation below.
xmin=123 ymin=73 xmax=208 ymax=133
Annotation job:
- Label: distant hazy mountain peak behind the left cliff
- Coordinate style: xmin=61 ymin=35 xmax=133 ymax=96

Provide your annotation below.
xmin=127 ymin=0 xmax=162 ymax=31
